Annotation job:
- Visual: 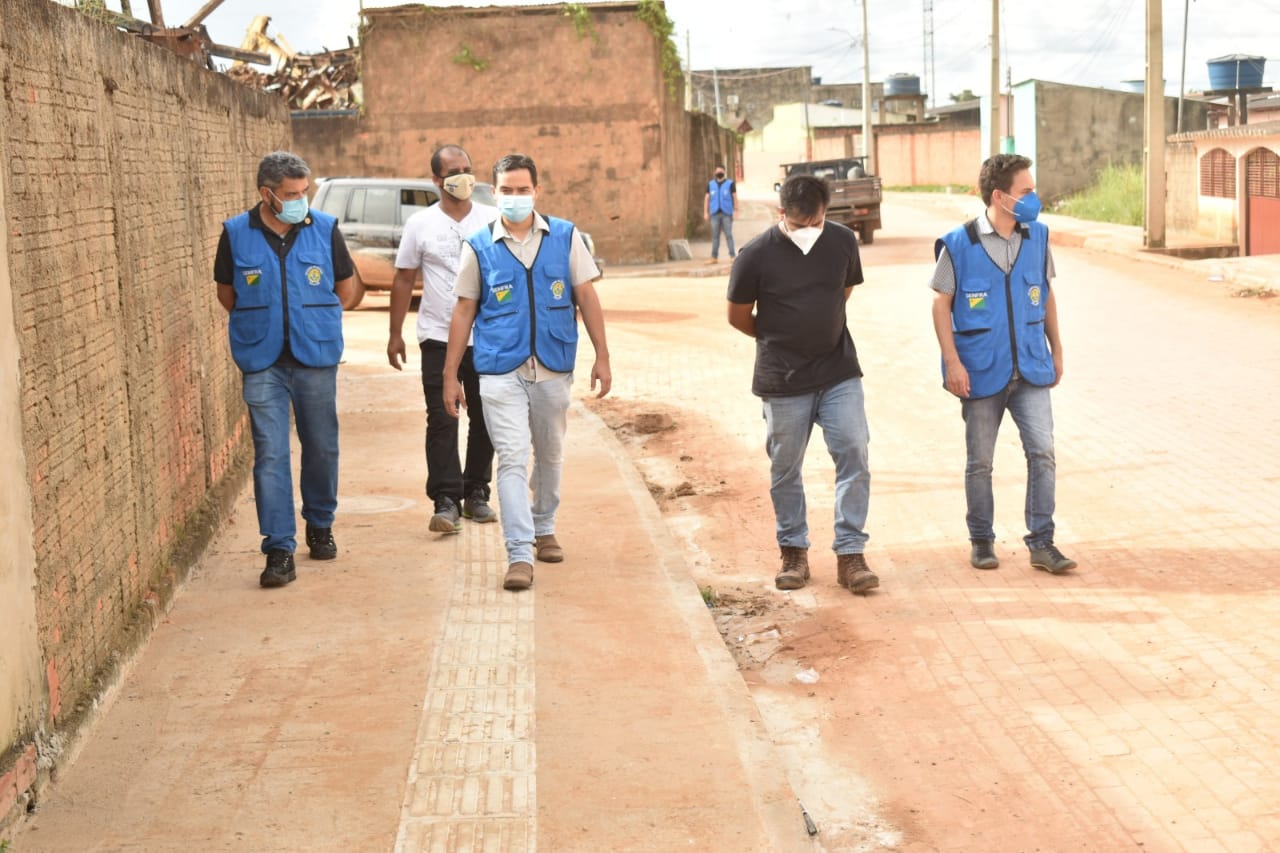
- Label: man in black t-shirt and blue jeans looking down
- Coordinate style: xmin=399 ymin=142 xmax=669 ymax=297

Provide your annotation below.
xmin=728 ymin=174 xmax=879 ymax=593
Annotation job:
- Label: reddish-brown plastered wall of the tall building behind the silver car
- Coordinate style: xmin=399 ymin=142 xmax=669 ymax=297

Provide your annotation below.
xmin=294 ymin=3 xmax=687 ymax=263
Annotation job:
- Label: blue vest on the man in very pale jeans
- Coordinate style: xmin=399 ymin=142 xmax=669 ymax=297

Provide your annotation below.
xmin=467 ymin=216 xmax=577 ymax=374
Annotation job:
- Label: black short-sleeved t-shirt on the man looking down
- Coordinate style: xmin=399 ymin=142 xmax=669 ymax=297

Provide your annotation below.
xmin=728 ymin=222 xmax=863 ymax=397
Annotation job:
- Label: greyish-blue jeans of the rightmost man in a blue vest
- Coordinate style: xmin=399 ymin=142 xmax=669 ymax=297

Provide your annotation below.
xmin=960 ymin=378 xmax=1056 ymax=548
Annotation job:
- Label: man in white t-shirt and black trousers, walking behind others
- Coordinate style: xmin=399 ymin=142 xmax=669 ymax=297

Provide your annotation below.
xmin=387 ymin=145 xmax=498 ymax=533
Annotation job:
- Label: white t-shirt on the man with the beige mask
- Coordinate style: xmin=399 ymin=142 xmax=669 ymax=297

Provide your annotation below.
xmin=396 ymin=202 xmax=498 ymax=346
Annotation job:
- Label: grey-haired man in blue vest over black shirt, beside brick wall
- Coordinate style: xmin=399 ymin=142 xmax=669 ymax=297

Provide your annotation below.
xmin=214 ymin=151 xmax=355 ymax=587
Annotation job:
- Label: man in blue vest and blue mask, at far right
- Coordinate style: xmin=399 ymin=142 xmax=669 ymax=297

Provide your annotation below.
xmin=932 ymin=154 xmax=1075 ymax=575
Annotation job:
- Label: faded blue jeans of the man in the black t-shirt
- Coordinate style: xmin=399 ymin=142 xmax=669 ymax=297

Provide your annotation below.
xmin=764 ymin=378 xmax=872 ymax=553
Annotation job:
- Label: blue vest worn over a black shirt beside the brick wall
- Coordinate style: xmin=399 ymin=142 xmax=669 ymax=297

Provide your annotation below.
xmin=224 ymin=210 xmax=342 ymax=373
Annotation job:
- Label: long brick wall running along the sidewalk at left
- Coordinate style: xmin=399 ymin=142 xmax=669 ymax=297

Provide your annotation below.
xmin=0 ymin=0 xmax=291 ymax=770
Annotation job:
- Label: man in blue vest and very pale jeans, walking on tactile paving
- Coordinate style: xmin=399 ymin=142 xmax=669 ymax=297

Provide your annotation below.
xmin=444 ymin=154 xmax=613 ymax=590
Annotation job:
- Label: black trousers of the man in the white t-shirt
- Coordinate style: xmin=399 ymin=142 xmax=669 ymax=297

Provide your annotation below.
xmin=419 ymin=341 xmax=493 ymax=506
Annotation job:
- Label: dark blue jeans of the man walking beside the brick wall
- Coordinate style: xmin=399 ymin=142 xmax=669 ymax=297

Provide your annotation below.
xmin=244 ymin=365 xmax=338 ymax=553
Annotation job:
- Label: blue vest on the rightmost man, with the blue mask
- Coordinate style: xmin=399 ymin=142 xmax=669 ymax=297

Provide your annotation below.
xmin=933 ymin=220 xmax=1055 ymax=400
